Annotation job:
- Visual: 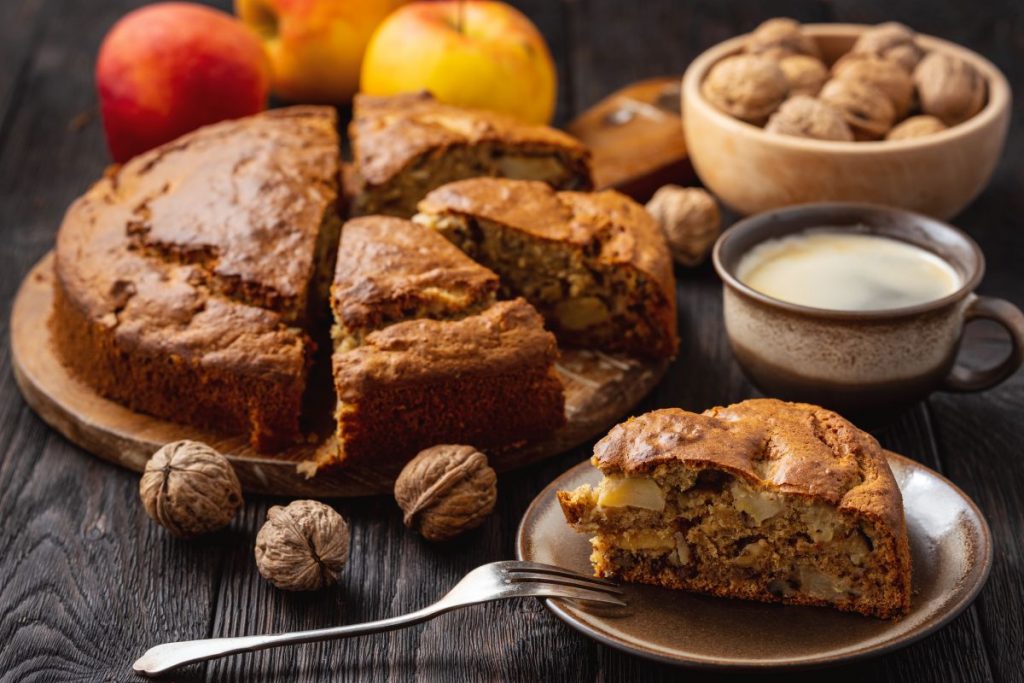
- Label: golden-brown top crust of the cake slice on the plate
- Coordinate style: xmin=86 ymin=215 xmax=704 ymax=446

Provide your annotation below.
xmin=594 ymin=398 xmax=903 ymax=528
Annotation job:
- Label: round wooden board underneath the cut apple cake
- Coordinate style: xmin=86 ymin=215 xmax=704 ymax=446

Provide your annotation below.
xmin=10 ymin=253 xmax=668 ymax=498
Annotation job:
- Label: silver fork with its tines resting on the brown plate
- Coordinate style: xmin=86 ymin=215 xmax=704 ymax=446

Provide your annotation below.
xmin=132 ymin=562 xmax=626 ymax=676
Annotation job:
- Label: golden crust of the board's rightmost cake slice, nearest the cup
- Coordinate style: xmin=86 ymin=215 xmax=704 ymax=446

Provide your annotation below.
xmin=411 ymin=178 xmax=677 ymax=356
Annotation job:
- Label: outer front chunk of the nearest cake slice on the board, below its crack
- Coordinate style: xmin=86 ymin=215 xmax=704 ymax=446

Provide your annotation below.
xmin=331 ymin=299 xmax=565 ymax=464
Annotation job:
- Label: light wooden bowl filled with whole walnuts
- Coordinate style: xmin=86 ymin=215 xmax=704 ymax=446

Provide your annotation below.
xmin=682 ymin=18 xmax=1011 ymax=219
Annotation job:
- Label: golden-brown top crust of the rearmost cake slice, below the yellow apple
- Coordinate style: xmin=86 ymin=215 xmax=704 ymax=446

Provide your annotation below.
xmin=349 ymin=92 xmax=590 ymax=185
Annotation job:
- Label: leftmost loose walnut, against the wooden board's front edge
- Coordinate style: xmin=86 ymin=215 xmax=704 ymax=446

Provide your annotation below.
xmin=138 ymin=441 xmax=242 ymax=539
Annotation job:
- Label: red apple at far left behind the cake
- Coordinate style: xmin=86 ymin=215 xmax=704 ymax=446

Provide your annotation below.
xmin=96 ymin=2 xmax=270 ymax=162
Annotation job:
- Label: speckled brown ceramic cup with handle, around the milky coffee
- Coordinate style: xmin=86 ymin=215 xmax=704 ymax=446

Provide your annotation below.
xmin=713 ymin=203 xmax=1024 ymax=416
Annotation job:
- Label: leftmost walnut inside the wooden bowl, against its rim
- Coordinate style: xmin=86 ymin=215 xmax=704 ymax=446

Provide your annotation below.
xmin=700 ymin=54 xmax=790 ymax=125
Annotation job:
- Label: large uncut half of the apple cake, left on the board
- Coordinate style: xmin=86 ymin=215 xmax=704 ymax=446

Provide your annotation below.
xmin=51 ymin=106 xmax=341 ymax=451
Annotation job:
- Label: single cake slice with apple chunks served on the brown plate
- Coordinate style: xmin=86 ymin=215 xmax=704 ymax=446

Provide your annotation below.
xmin=558 ymin=399 xmax=910 ymax=617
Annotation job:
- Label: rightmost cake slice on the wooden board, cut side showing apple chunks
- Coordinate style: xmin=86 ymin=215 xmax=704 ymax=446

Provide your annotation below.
xmin=414 ymin=178 xmax=678 ymax=357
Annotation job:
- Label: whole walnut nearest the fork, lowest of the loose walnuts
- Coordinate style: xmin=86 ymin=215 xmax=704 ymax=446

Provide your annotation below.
xmin=256 ymin=501 xmax=348 ymax=591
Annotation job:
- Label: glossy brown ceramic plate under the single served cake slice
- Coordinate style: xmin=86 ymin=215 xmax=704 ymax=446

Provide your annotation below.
xmin=516 ymin=453 xmax=992 ymax=670
